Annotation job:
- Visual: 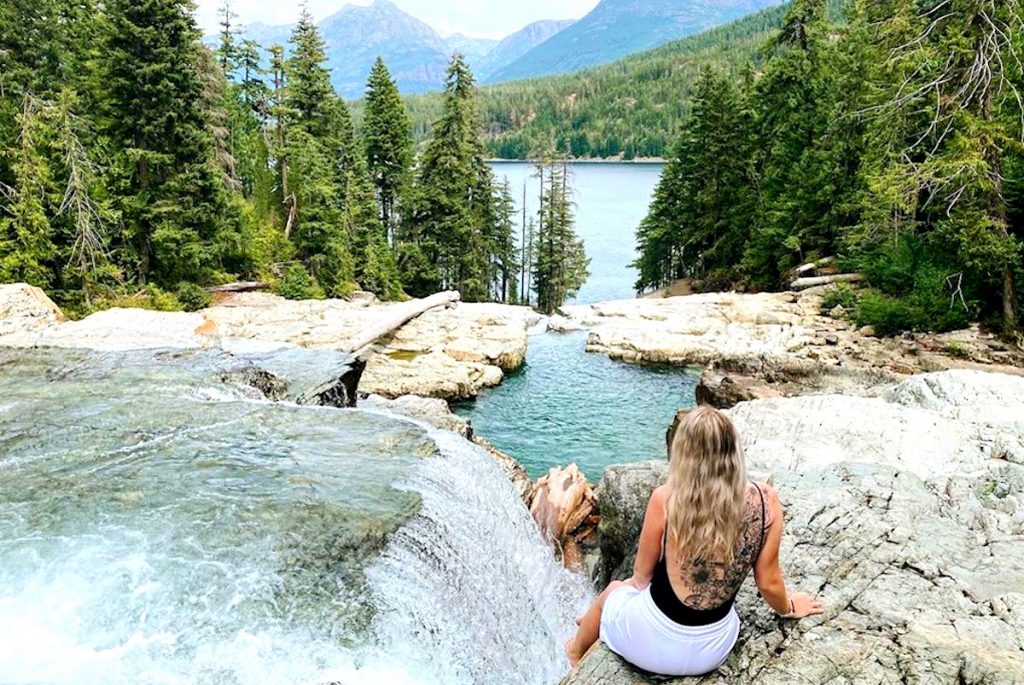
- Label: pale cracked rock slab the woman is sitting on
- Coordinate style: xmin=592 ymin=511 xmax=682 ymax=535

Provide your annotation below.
xmin=562 ymin=371 xmax=1024 ymax=685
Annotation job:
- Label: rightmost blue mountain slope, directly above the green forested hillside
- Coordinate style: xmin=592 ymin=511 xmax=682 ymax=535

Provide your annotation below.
xmin=489 ymin=0 xmax=782 ymax=82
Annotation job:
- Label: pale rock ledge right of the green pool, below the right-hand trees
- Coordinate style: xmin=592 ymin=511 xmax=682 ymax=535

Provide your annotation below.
xmin=552 ymin=288 xmax=1024 ymax=406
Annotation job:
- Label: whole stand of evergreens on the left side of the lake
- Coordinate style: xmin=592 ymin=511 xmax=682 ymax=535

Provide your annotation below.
xmin=0 ymin=0 xmax=518 ymax=313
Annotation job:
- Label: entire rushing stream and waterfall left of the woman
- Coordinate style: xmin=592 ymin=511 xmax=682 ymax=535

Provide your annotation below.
xmin=0 ymin=350 xmax=587 ymax=685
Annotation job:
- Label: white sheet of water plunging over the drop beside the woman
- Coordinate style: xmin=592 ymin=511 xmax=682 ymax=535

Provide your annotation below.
xmin=367 ymin=421 xmax=592 ymax=685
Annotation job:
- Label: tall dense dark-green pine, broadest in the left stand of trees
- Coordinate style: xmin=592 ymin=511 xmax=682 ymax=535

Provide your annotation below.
xmin=108 ymin=0 xmax=238 ymax=286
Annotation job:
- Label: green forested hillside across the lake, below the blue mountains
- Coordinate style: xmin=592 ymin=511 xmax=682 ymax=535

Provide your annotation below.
xmin=385 ymin=3 xmax=790 ymax=159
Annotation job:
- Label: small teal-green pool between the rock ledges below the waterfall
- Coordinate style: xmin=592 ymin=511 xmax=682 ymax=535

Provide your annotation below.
xmin=453 ymin=333 xmax=697 ymax=482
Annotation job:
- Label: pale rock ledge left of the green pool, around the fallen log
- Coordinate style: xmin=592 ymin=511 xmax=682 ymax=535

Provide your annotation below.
xmin=0 ymin=284 xmax=538 ymax=399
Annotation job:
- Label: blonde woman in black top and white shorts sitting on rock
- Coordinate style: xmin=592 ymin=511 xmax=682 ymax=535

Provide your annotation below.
xmin=565 ymin=408 xmax=821 ymax=676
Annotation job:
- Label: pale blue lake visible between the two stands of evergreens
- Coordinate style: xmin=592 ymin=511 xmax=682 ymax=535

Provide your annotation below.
xmin=492 ymin=162 xmax=663 ymax=304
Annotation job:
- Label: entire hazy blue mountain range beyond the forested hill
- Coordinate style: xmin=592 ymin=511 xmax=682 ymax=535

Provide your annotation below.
xmin=211 ymin=0 xmax=782 ymax=98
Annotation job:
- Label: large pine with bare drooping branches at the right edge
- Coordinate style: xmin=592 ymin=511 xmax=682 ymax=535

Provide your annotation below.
xmin=860 ymin=0 xmax=1024 ymax=330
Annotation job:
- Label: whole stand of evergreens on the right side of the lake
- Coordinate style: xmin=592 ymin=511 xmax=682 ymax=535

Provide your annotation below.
xmin=637 ymin=0 xmax=1024 ymax=335
